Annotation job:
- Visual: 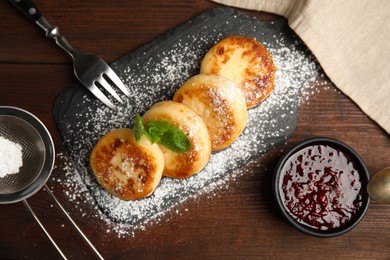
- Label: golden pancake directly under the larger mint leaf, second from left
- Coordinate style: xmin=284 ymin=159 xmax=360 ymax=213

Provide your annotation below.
xmin=142 ymin=101 xmax=211 ymax=179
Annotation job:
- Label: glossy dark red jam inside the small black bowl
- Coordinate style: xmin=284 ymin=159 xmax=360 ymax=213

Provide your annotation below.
xmin=279 ymin=145 xmax=362 ymax=230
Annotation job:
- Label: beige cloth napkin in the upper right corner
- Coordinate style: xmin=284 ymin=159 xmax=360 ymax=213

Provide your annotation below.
xmin=213 ymin=0 xmax=390 ymax=134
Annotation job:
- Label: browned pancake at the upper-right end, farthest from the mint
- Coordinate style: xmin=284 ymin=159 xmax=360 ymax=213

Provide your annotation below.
xmin=200 ymin=36 xmax=276 ymax=109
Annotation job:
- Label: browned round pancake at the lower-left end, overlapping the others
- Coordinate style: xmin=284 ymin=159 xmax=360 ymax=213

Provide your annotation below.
xmin=90 ymin=128 xmax=164 ymax=200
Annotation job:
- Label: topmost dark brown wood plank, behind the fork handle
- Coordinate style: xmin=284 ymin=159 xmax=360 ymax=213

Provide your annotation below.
xmin=0 ymin=0 xmax=216 ymax=63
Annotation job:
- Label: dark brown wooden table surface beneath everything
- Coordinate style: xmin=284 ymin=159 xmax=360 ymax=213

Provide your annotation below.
xmin=0 ymin=0 xmax=390 ymax=259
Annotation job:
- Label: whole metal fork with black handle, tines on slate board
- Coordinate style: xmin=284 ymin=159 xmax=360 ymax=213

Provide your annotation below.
xmin=8 ymin=0 xmax=130 ymax=111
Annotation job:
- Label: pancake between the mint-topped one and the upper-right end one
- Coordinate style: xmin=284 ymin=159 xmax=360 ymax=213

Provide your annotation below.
xmin=173 ymin=74 xmax=247 ymax=151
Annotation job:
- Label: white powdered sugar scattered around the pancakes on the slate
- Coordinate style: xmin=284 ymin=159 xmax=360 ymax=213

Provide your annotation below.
xmin=51 ymin=9 xmax=321 ymax=236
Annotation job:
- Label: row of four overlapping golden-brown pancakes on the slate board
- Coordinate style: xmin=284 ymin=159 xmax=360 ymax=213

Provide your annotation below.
xmin=90 ymin=36 xmax=276 ymax=200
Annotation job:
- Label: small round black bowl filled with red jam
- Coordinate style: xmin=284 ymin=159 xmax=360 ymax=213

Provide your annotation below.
xmin=273 ymin=137 xmax=370 ymax=237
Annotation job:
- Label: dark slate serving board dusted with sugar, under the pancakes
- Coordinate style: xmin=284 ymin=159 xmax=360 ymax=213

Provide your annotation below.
xmin=53 ymin=8 xmax=320 ymax=227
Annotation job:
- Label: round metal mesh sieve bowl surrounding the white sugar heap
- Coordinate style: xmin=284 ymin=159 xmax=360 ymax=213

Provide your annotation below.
xmin=0 ymin=106 xmax=55 ymax=201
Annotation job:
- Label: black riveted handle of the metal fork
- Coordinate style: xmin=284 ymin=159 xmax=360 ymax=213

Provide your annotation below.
xmin=7 ymin=0 xmax=76 ymax=58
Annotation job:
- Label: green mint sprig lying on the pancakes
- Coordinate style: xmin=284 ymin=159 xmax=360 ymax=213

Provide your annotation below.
xmin=133 ymin=114 xmax=191 ymax=153
